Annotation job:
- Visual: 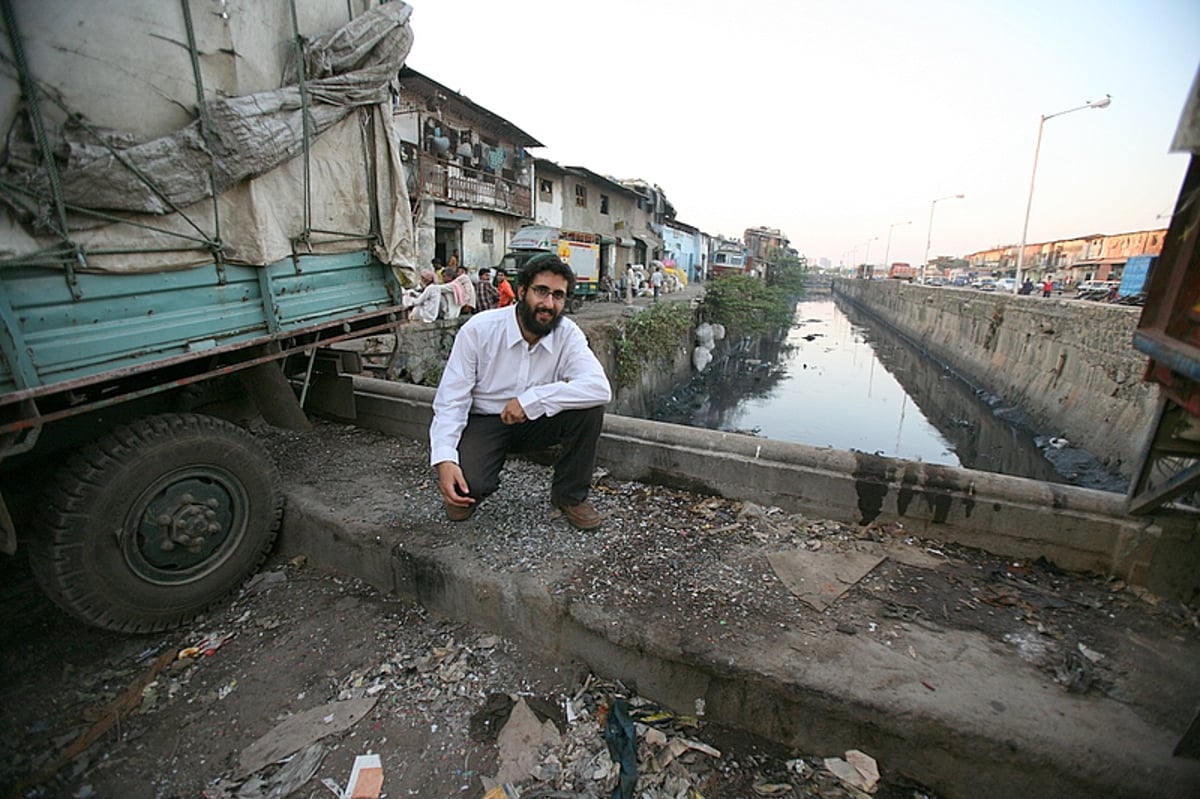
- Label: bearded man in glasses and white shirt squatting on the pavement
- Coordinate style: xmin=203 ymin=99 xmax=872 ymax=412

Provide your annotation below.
xmin=430 ymin=253 xmax=612 ymax=530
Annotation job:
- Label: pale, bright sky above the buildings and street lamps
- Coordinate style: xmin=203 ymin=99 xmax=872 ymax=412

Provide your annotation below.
xmin=408 ymin=0 xmax=1200 ymax=265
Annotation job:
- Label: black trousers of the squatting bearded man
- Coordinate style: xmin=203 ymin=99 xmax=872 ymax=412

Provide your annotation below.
xmin=458 ymin=405 xmax=604 ymax=505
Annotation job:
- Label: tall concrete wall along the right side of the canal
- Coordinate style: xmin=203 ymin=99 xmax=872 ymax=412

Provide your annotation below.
xmin=834 ymin=280 xmax=1158 ymax=477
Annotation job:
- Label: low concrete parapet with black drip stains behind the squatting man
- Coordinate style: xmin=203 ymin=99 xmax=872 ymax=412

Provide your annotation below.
xmin=338 ymin=378 xmax=1200 ymax=600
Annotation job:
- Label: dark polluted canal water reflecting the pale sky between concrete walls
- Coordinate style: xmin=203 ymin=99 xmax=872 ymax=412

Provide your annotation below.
xmin=653 ymin=298 xmax=1126 ymax=492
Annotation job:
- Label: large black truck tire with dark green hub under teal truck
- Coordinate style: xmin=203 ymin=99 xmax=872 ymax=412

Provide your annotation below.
xmin=30 ymin=414 xmax=283 ymax=632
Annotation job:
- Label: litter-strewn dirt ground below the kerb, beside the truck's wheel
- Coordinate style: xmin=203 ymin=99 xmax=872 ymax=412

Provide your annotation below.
xmin=0 ymin=535 xmax=934 ymax=799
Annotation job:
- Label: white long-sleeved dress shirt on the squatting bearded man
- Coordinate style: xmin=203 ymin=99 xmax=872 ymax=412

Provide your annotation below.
xmin=430 ymin=305 xmax=612 ymax=464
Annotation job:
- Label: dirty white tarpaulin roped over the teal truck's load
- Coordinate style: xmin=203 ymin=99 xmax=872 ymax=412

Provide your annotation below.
xmin=0 ymin=0 xmax=414 ymax=272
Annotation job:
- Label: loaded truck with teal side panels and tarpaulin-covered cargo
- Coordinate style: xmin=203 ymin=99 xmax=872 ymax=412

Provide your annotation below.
xmin=0 ymin=0 xmax=415 ymax=632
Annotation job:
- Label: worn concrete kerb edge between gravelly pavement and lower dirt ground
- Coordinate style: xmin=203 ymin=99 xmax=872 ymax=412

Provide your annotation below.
xmin=280 ymin=488 xmax=1200 ymax=799
